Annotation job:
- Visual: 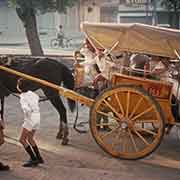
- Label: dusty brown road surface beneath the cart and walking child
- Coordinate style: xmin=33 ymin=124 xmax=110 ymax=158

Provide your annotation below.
xmin=0 ymin=96 xmax=180 ymax=180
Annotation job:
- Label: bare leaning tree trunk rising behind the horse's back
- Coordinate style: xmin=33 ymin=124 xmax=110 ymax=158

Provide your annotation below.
xmin=16 ymin=8 xmax=43 ymax=56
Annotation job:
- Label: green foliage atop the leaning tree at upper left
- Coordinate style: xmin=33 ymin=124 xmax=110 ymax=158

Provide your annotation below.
xmin=8 ymin=0 xmax=78 ymax=13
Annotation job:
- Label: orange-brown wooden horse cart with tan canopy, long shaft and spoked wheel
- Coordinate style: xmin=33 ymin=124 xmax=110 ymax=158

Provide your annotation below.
xmin=0 ymin=23 xmax=180 ymax=159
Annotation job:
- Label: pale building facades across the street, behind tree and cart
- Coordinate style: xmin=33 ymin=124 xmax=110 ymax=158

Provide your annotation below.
xmin=0 ymin=0 xmax=179 ymax=45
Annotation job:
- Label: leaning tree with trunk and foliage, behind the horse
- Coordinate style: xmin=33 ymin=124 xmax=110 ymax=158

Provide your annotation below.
xmin=8 ymin=0 xmax=77 ymax=56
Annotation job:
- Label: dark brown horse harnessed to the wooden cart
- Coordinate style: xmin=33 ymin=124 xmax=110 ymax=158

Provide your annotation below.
xmin=0 ymin=57 xmax=76 ymax=145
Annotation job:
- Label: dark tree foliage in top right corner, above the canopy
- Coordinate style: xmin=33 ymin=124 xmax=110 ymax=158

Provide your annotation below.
xmin=161 ymin=0 xmax=180 ymax=28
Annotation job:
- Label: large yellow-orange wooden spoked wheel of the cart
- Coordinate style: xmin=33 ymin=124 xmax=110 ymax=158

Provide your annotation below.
xmin=90 ymin=85 xmax=165 ymax=159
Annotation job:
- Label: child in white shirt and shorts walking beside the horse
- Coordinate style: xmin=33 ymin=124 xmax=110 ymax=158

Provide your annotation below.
xmin=17 ymin=78 xmax=44 ymax=167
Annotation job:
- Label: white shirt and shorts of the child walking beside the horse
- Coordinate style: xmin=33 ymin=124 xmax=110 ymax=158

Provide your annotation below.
xmin=20 ymin=91 xmax=40 ymax=131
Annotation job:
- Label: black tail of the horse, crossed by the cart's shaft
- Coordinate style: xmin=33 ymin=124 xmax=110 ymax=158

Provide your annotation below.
xmin=62 ymin=64 xmax=76 ymax=112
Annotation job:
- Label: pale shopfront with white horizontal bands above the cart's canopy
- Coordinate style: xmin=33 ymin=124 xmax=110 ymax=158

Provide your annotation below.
xmin=117 ymin=0 xmax=169 ymax=25
